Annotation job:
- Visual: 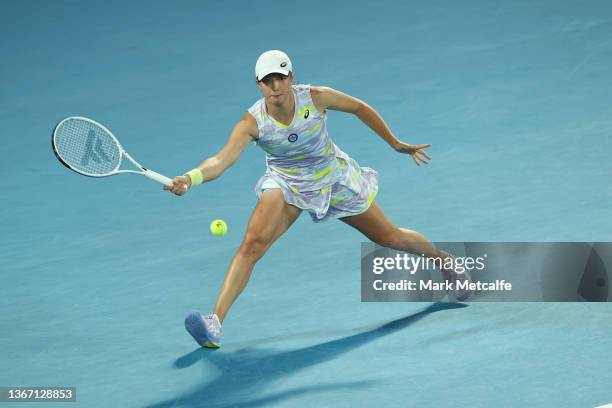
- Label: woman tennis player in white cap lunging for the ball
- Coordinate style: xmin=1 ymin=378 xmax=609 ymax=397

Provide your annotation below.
xmin=164 ymin=50 xmax=470 ymax=347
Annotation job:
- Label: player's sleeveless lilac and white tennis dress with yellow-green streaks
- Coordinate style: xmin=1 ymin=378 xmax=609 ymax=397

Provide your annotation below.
xmin=249 ymin=85 xmax=378 ymax=222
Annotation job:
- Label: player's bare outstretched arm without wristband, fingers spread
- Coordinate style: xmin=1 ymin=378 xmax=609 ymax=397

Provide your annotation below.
xmin=310 ymin=86 xmax=431 ymax=165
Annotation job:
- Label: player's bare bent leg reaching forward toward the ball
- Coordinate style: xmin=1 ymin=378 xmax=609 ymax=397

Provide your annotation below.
xmin=214 ymin=189 xmax=302 ymax=322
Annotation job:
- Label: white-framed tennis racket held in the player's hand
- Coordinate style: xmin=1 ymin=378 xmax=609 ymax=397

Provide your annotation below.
xmin=51 ymin=116 xmax=172 ymax=186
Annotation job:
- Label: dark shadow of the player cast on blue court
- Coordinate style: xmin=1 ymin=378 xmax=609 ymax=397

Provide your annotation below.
xmin=148 ymin=303 xmax=468 ymax=408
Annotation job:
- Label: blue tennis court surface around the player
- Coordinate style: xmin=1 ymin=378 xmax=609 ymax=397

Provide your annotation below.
xmin=0 ymin=0 xmax=612 ymax=408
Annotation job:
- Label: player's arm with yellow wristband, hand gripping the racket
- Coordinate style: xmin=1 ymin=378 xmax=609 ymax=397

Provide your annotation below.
xmin=164 ymin=112 xmax=259 ymax=195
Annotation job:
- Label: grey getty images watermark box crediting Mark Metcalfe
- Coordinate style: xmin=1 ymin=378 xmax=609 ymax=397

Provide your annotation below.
xmin=361 ymin=242 xmax=612 ymax=302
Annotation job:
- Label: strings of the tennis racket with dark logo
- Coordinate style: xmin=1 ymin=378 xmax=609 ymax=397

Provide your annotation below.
xmin=53 ymin=119 xmax=121 ymax=176
